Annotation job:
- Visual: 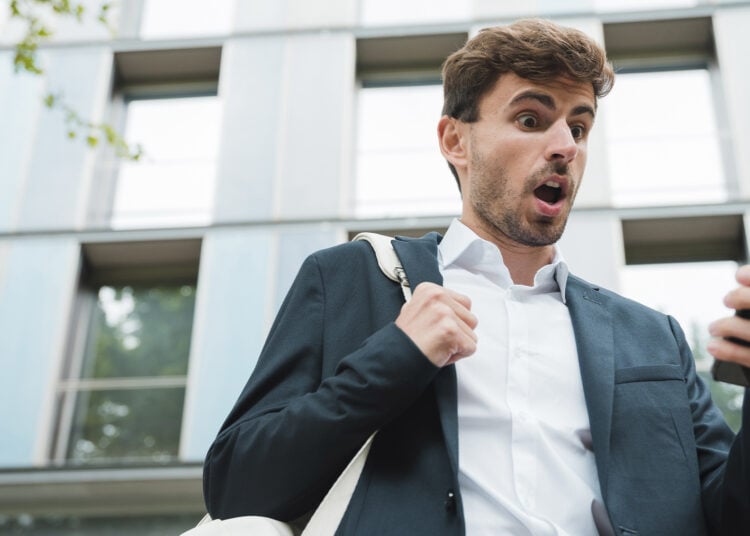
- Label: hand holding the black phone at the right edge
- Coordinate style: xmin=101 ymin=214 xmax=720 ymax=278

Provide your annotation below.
xmin=707 ymin=265 xmax=750 ymax=367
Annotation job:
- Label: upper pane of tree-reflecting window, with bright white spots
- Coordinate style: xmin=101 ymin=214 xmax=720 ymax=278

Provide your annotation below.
xmin=81 ymin=285 xmax=195 ymax=378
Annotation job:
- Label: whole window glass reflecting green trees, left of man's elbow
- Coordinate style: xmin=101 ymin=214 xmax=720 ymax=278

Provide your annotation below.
xmin=56 ymin=282 xmax=195 ymax=464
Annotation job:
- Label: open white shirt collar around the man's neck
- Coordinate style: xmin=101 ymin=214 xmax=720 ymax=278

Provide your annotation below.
xmin=438 ymin=219 xmax=569 ymax=303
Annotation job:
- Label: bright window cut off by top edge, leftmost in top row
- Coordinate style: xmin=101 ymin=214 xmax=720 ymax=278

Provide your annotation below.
xmin=141 ymin=0 xmax=235 ymax=39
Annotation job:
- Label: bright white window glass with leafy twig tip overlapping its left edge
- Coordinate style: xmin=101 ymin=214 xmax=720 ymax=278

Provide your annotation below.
xmin=111 ymin=96 xmax=221 ymax=228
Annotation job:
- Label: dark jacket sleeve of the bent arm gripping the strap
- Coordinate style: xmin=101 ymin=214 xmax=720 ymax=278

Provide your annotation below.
xmin=203 ymin=252 xmax=439 ymax=521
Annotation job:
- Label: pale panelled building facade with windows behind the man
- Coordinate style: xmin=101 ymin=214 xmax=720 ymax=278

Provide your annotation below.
xmin=0 ymin=0 xmax=750 ymax=535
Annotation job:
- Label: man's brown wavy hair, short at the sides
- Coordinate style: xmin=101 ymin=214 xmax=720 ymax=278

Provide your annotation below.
xmin=443 ymin=19 xmax=615 ymax=184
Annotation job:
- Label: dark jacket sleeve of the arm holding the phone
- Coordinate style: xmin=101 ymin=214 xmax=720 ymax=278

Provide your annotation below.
xmin=670 ymin=318 xmax=750 ymax=536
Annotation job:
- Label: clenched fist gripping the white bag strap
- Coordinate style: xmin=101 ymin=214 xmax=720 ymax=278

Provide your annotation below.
xmin=396 ymin=283 xmax=477 ymax=367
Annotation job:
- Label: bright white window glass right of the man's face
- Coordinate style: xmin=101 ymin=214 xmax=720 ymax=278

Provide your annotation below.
xmin=602 ymin=69 xmax=727 ymax=206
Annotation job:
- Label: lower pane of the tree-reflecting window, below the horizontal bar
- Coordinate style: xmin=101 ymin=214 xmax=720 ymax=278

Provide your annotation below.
xmin=67 ymin=387 xmax=185 ymax=463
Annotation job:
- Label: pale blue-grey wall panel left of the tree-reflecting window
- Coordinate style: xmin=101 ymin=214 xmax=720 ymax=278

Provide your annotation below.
xmin=0 ymin=238 xmax=79 ymax=467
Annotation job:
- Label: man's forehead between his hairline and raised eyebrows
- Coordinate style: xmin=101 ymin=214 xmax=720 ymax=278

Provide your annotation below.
xmin=479 ymin=72 xmax=596 ymax=114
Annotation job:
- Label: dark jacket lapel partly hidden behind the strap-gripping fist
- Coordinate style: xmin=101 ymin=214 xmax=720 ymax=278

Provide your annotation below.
xmin=392 ymin=233 xmax=458 ymax=475
